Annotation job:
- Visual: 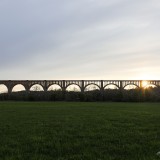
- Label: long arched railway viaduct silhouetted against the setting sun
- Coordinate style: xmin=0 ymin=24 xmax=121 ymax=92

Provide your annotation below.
xmin=0 ymin=80 xmax=160 ymax=94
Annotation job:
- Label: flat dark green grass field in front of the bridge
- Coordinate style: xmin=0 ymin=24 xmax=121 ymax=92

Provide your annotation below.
xmin=0 ymin=102 xmax=160 ymax=160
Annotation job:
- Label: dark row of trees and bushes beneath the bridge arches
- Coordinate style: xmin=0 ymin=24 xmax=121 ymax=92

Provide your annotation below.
xmin=0 ymin=87 xmax=160 ymax=102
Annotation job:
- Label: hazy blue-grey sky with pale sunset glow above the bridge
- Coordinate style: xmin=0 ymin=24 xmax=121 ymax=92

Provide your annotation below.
xmin=0 ymin=0 xmax=160 ymax=79
